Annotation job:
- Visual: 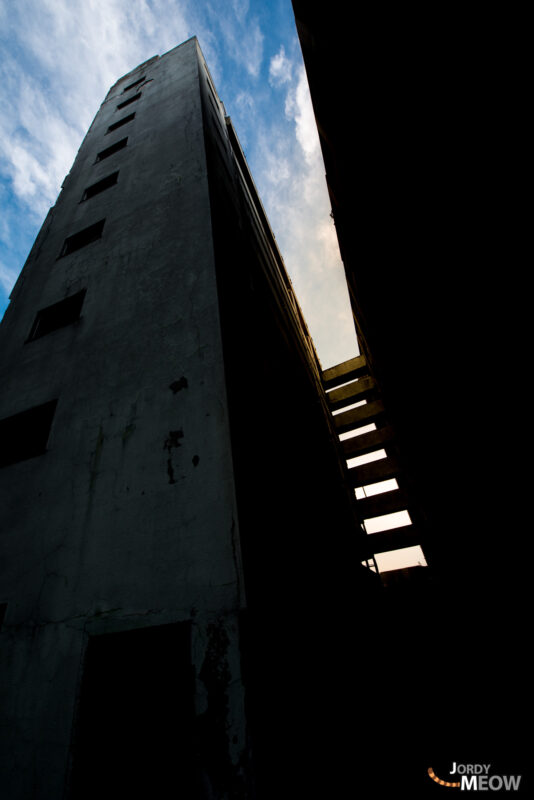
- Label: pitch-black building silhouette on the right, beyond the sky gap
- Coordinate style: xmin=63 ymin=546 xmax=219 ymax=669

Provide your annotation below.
xmin=293 ymin=0 xmax=530 ymax=796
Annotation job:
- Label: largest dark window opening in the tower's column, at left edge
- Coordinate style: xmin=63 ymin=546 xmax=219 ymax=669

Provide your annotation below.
xmin=0 ymin=400 xmax=57 ymax=467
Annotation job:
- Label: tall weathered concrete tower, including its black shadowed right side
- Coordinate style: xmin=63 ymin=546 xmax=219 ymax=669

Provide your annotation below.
xmin=0 ymin=39 xmax=390 ymax=800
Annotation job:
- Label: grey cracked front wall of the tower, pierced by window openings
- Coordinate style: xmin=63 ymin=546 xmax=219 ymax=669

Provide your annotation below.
xmin=0 ymin=39 xmax=249 ymax=799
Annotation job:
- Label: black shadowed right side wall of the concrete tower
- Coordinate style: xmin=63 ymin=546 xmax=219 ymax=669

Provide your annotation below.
xmin=201 ymin=67 xmax=394 ymax=798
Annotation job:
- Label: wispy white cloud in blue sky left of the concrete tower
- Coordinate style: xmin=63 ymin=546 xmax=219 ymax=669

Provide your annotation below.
xmin=0 ymin=0 xmax=195 ymax=215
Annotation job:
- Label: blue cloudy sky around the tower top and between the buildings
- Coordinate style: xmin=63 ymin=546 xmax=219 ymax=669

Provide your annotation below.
xmin=0 ymin=0 xmax=357 ymax=367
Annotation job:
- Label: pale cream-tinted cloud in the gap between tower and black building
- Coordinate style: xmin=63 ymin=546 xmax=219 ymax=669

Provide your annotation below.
xmin=248 ymin=62 xmax=358 ymax=367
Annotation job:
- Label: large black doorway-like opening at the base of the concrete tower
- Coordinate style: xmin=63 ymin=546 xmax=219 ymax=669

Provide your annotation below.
xmin=70 ymin=622 xmax=199 ymax=800
